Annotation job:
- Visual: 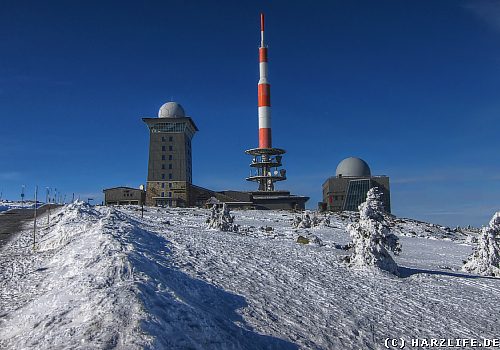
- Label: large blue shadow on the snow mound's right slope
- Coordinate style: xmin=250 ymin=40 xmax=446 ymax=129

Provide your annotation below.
xmin=123 ymin=213 xmax=298 ymax=349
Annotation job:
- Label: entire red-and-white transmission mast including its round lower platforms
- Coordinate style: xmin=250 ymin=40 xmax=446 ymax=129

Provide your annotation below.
xmin=245 ymin=13 xmax=286 ymax=192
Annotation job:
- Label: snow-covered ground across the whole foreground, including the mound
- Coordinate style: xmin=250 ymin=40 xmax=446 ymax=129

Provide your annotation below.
xmin=0 ymin=204 xmax=500 ymax=349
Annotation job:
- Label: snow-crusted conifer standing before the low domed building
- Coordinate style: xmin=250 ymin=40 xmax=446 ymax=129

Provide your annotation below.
xmin=347 ymin=187 xmax=401 ymax=274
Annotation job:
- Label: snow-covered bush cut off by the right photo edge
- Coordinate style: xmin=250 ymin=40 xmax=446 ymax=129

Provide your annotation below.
xmin=462 ymin=211 xmax=500 ymax=277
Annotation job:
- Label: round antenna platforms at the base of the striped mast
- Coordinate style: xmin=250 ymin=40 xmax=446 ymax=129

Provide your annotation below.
xmin=245 ymin=148 xmax=286 ymax=192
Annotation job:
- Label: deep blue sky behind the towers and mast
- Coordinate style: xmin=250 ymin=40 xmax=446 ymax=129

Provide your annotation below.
xmin=0 ymin=0 xmax=500 ymax=226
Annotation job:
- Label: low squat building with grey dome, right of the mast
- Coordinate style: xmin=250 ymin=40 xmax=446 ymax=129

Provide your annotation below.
xmin=320 ymin=157 xmax=391 ymax=213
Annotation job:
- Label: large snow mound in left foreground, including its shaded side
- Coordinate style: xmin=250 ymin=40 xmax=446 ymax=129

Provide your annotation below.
xmin=0 ymin=203 xmax=293 ymax=349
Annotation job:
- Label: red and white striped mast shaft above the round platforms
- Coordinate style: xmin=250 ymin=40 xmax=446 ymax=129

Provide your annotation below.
xmin=258 ymin=13 xmax=272 ymax=148
